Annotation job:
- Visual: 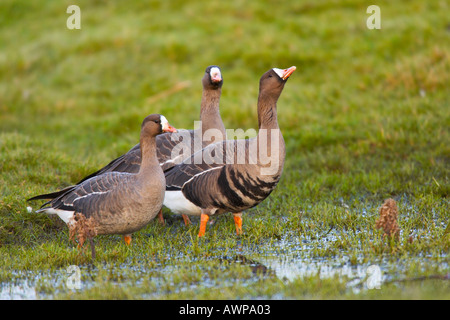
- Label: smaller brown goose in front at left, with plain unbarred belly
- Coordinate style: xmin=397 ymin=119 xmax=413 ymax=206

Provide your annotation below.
xmin=36 ymin=114 xmax=175 ymax=251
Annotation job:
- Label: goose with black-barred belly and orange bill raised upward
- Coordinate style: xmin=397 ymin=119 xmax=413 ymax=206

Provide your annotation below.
xmin=164 ymin=67 xmax=296 ymax=237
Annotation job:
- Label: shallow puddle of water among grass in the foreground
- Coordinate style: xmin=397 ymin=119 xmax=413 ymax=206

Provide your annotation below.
xmin=0 ymin=226 xmax=449 ymax=300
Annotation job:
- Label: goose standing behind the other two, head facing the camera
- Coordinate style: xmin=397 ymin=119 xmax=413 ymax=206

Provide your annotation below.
xmin=28 ymin=65 xmax=226 ymax=224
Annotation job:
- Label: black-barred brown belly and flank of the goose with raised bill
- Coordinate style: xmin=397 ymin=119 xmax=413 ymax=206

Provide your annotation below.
xmin=183 ymin=165 xmax=280 ymax=213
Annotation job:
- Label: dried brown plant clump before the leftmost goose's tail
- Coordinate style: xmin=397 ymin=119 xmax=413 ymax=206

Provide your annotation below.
xmin=69 ymin=212 xmax=97 ymax=259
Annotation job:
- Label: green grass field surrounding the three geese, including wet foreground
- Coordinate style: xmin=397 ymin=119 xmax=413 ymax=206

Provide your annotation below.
xmin=0 ymin=0 xmax=450 ymax=300
